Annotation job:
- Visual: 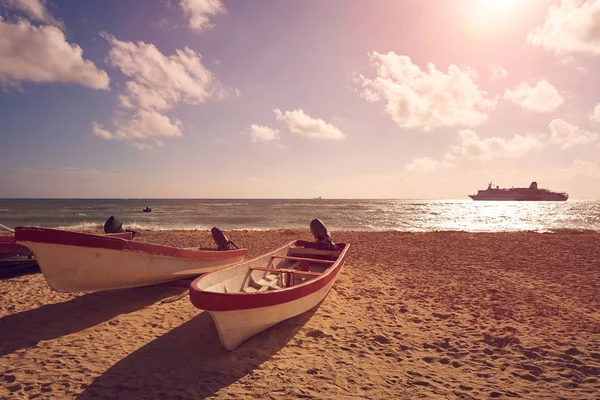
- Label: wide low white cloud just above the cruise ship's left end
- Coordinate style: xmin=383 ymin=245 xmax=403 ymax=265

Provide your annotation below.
xmin=449 ymin=129 xmax=544 ymax=161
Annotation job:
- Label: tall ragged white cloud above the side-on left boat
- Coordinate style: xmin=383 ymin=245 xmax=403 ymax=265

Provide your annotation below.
xmin=93 ymin=33 xmax=224 ymax=150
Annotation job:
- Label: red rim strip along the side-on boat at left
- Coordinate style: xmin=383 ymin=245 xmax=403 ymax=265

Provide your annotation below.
xmin=15 ymin=227 xmax=247 ymax=260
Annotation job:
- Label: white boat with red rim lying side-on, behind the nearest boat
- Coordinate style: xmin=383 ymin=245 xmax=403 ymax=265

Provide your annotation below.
xmin=15 ymin=227 xmax=246 ymax=292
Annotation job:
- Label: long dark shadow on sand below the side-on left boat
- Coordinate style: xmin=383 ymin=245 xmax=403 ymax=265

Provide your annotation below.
xmin=0 ymin=286 xmax=184 ymax=356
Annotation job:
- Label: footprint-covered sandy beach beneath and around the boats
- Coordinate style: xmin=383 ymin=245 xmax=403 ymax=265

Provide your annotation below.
xmin=0 ymin=230 xmax=600 ymax=399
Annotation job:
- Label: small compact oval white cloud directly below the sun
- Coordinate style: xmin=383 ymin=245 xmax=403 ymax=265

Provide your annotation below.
xmin=504 ymin=80 xmax=564 ymax=113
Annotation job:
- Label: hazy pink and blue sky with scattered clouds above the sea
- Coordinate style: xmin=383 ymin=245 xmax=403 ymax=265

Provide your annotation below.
xmin=0 ymin=0 xmax=600 ymax=200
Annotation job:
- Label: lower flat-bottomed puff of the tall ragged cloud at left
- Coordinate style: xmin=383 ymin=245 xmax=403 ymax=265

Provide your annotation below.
xmin=92 ymin=110 xmax=182 ymax=148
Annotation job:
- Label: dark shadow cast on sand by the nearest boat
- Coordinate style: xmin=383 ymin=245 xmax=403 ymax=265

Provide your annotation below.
xmin=77 ymin=304 xmax=320 ymax=400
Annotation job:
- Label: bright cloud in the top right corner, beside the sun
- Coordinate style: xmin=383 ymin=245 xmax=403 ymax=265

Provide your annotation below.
xmin=527 ymin=0 xmax=600 ymax=54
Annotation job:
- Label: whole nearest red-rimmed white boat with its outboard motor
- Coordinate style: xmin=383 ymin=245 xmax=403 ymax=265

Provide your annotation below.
xmin=190 ymin=220 xmax=349 ymax=350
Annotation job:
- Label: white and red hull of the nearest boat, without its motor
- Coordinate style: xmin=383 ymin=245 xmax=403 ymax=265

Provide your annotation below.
xmin=190 ymin=242 xmax=349 ymax=350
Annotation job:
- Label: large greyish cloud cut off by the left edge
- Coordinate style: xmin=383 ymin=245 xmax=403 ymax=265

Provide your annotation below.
xmin=0 ymin=17 xmax=110 ymax=89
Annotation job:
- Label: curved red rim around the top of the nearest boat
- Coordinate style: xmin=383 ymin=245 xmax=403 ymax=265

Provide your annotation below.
xmin=190 ymin=240 xmax=350 ymax=311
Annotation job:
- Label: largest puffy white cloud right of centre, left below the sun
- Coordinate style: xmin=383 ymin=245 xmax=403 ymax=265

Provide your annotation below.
xmin=357 ymin=52 xmax=496 ymax=130
